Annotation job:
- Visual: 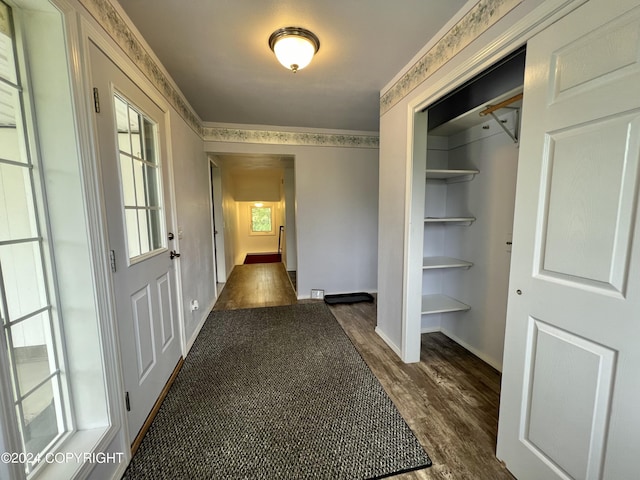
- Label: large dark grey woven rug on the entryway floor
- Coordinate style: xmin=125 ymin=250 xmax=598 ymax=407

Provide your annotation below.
xmin=123 ymin=303 xmax=431 ymax=480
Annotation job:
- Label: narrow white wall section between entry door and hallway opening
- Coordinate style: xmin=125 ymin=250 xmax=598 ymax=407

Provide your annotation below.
xmin=169 ymin=109 xmax=217 ymax=345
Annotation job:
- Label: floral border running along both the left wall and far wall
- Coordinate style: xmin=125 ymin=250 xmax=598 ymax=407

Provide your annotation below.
xmin=79 ymin=0 xmax=379 ymax=148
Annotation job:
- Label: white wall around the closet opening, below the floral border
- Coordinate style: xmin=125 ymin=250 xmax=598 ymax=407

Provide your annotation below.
xmin=377 ymin=0 xmax=544 ymax=361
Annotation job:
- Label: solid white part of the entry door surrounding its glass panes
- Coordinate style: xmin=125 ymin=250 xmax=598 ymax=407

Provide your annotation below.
xmin=89 ymin=44 xmax=181 ymax=442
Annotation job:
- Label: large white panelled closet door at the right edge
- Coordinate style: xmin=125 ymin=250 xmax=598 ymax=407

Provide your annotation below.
xmin=497 ymin=0 xmax=640 ymax=480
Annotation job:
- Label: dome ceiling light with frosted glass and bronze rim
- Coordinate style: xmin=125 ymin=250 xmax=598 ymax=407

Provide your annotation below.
xmin=269 ymin=27 xmax=320 ymax=73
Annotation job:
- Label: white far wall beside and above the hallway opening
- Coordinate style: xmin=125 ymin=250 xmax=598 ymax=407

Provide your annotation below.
xmin=205 ymin=137 xmax=378 ymax=298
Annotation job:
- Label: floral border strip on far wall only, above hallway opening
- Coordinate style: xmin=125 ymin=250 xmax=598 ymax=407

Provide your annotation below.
xmin=202 ymin=126 xmax=380 ymax=148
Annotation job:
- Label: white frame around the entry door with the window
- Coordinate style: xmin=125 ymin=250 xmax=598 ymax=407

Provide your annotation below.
xmin=81 ymin=25 xmax=186 ymax=446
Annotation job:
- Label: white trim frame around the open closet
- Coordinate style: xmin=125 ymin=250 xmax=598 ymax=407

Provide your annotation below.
xmin=399 ymin=0 xmax=587 ymax=363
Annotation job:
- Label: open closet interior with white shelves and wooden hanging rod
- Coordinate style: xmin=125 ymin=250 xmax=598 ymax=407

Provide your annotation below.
xmin=414 ymin=49 xmax=525 ymax=370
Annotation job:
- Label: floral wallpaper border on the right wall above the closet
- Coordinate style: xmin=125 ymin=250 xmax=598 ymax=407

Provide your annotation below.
xmin=380 ymin=0 xmax=523 ymax=116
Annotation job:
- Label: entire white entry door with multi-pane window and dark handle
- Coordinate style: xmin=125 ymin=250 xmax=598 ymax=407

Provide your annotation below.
xmin=90 ymin=45 xmax=181 ymax=441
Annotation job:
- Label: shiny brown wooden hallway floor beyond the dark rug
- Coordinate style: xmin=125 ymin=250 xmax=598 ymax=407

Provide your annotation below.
xmin=213 ymin=263 xmax=297 ymax=310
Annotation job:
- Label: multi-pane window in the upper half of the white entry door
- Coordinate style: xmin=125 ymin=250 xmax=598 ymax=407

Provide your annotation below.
xmin=114 ymin=94 xmax=166 ymax=259
